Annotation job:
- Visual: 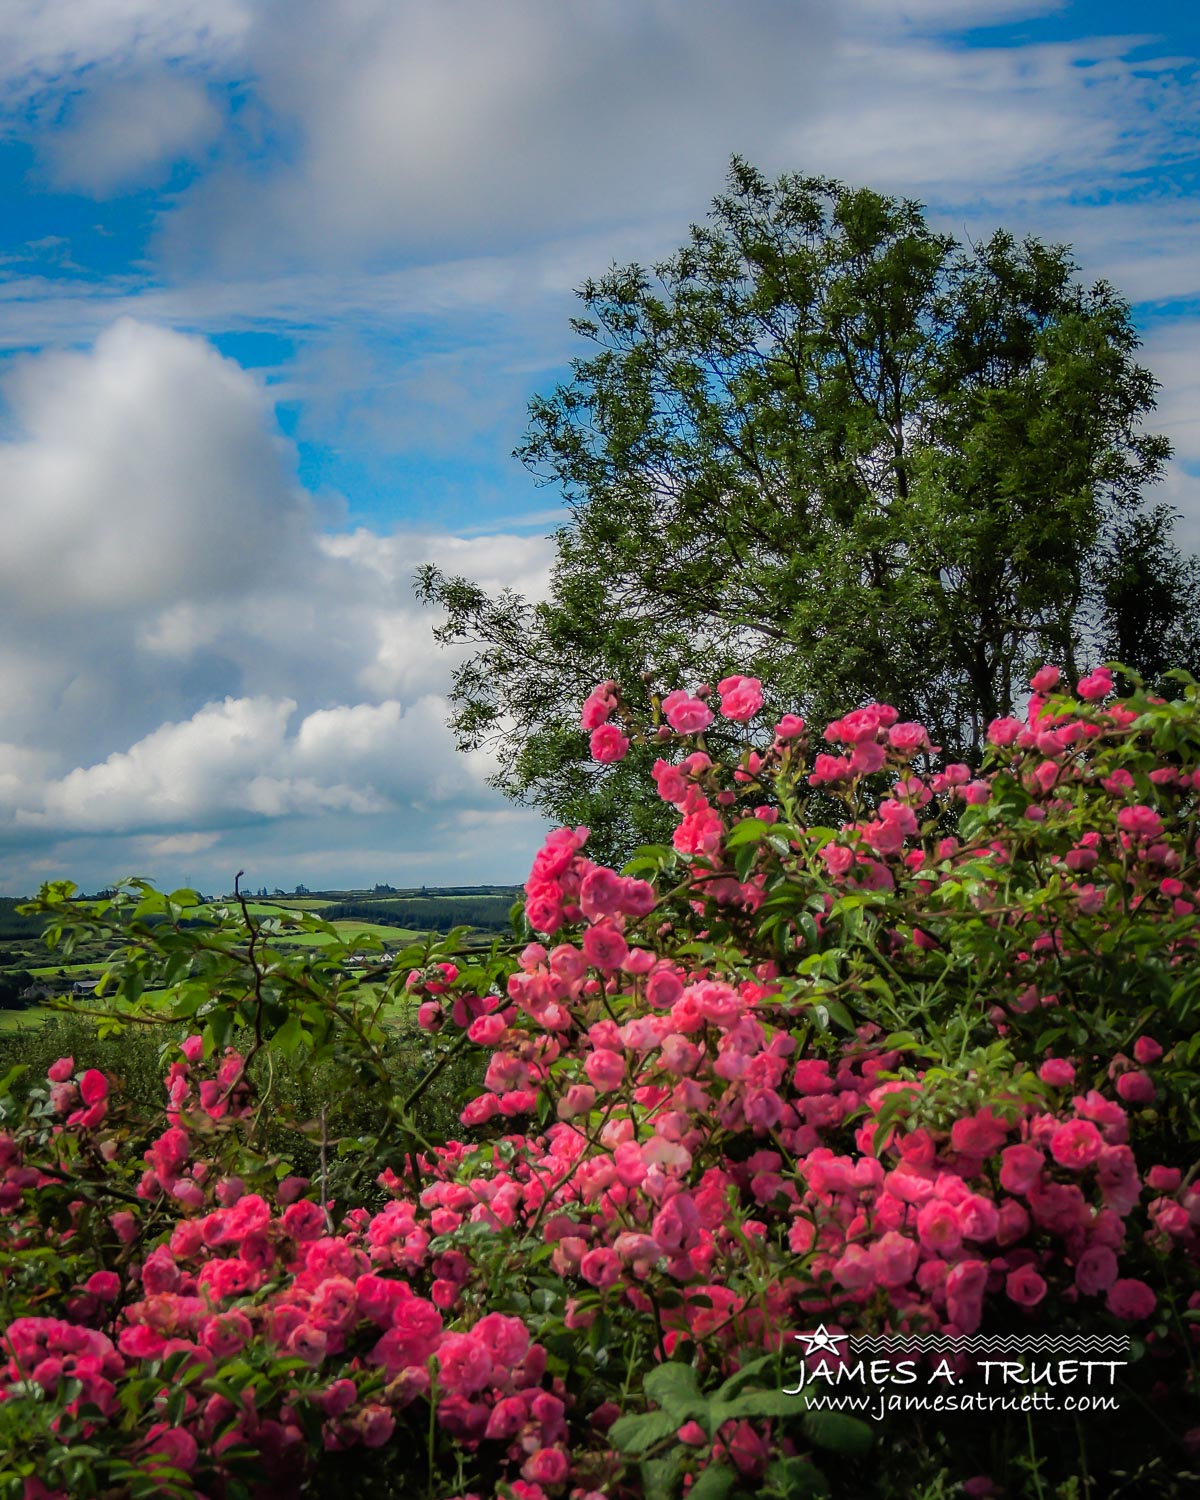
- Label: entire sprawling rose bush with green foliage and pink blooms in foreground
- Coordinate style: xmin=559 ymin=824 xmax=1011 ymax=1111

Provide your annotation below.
xmin=0 ymin=668 xmax=1200 ymax=1500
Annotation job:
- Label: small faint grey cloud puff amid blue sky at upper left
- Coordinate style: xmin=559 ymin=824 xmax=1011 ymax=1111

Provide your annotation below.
xmin=45 ymin=72 xmax=222 ymax=198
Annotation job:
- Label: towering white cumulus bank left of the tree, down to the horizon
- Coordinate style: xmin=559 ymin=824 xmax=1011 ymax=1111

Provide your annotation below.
xmin=0 ymin=320 xmax=551 ymax=881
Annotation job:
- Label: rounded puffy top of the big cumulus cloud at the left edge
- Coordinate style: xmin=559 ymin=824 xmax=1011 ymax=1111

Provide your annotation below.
xmin=0 ymin=320 xmax=305 ymax=617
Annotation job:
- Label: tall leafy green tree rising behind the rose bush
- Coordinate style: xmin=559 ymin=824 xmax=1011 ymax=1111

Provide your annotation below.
xmin=417 ymin=158 xmax=1184 ymax=857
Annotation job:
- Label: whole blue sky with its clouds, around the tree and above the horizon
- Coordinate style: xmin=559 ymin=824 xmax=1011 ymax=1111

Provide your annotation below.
xmin=0 ymin=0 xmax=1200 ymax=893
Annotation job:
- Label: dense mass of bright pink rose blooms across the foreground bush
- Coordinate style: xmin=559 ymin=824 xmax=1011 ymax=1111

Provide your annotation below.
xmin=0 ymin=668 xmax=1200 ymax=1500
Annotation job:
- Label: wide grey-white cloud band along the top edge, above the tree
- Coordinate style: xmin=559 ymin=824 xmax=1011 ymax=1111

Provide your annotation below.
xmin=131 ymin=0 xmax=1196 ymax=275
